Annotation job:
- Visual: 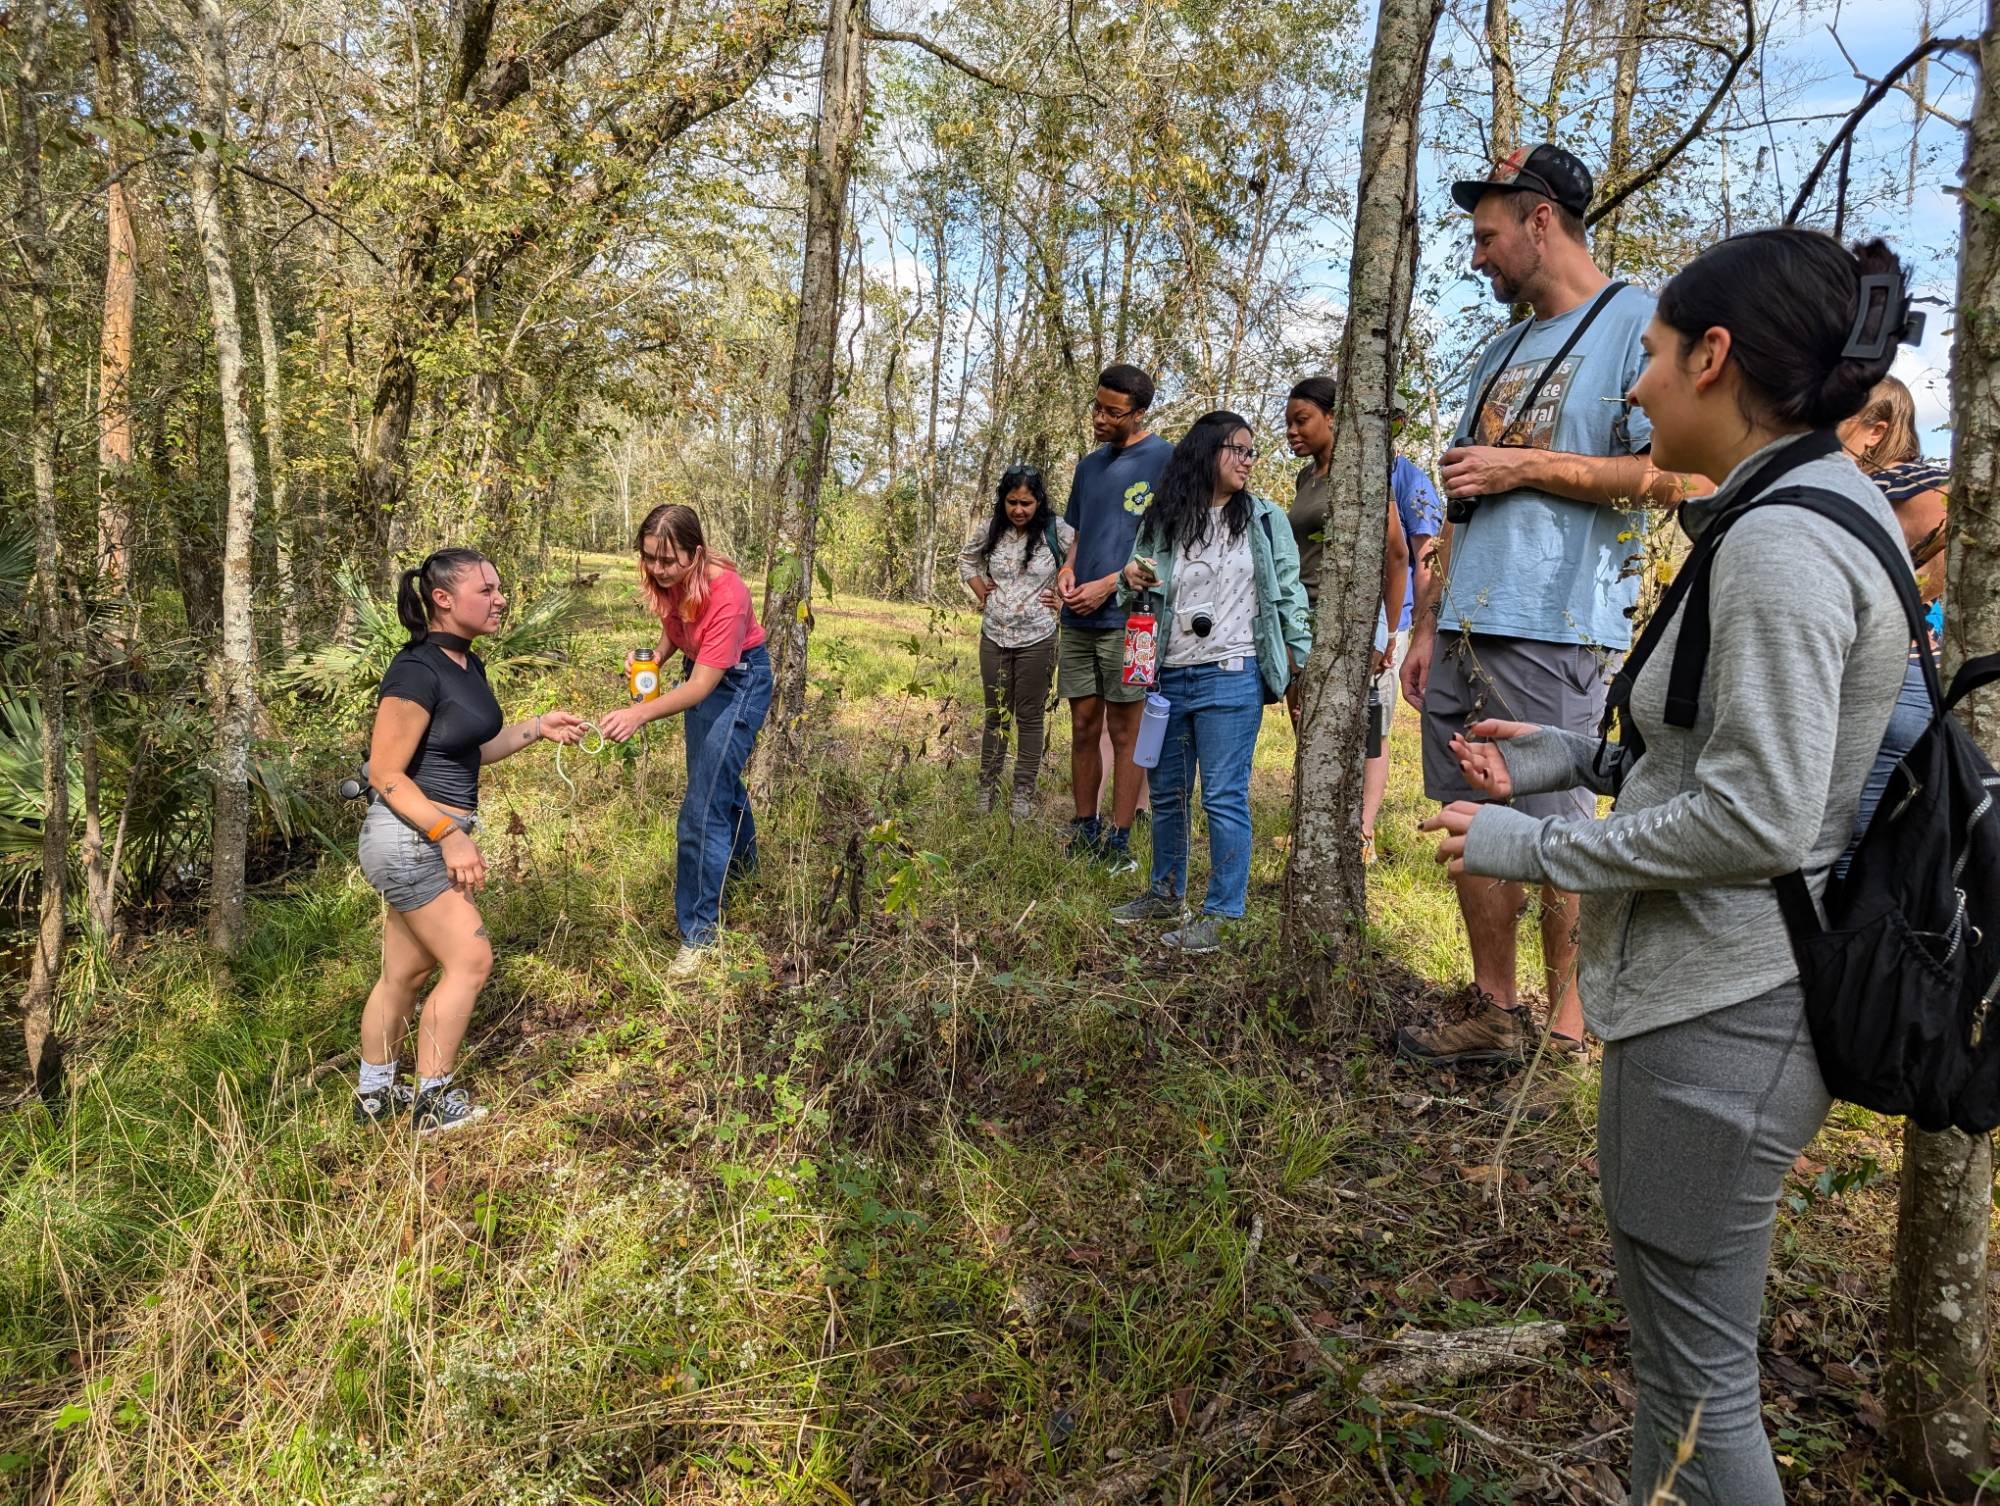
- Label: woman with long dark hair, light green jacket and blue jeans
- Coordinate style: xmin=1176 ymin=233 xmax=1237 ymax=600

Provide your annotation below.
xmin=1112 ymin=410 xmax=1312 ymax=954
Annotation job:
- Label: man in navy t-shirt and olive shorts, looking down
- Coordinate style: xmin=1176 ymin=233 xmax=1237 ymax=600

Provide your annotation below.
xmin=1056 ymin=362 xmax=1174 ymax=874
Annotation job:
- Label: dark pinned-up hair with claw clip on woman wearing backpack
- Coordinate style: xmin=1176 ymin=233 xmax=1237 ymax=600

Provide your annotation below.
xmin=1660 ymin=230 xmax=1908 ymax=428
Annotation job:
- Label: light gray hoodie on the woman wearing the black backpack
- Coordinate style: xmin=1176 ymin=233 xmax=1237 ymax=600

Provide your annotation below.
xmin=1466 ymin=436 xmax=1910 ymax=1040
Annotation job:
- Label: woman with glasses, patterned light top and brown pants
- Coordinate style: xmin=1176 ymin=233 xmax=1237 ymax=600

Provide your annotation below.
xmin=958 ymin=464 xmax=1076 ymax=820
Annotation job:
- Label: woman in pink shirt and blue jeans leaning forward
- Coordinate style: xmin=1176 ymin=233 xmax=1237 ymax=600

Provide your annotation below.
xmin=600 ymin=504 xmax=770 ymax=978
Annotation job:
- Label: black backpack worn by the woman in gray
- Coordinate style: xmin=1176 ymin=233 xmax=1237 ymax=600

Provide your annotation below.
xmin=1606 ymin=432 xmax=2000 ymax=1134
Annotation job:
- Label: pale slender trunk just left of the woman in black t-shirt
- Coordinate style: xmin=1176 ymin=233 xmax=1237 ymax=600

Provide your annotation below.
xmin=188 ymin=0 xmax=256 ymax=952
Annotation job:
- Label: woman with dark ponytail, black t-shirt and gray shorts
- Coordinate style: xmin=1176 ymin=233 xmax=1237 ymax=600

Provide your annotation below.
xmin=354 ymin=548 xmax=584 ymax=1134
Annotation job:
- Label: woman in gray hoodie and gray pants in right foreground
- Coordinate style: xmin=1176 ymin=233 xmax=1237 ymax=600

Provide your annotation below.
xmin=1428 ymin=230 xmax=1910 ymax=1506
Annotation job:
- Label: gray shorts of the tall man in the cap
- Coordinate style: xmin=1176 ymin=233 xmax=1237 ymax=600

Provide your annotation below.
xmin=1424 ymin=628 xmax=1624 ymax=820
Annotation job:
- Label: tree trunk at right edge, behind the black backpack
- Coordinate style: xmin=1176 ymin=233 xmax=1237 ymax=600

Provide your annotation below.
xmin=1884 ymin=0 xmax=2000 ymax=1500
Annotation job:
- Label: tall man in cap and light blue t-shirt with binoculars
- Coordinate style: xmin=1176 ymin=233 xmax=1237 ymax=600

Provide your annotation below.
xmin=1398 ymin=144 xmax=1714 ymax=1066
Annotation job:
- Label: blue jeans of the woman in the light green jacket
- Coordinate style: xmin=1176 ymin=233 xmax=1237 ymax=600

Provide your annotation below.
xmin=1150 ymin=656 xmax=1264 ymax=920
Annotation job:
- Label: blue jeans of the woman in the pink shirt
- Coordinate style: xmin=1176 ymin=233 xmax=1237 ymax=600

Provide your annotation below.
xmin=674 ymin=644 xmax=770 ymax=946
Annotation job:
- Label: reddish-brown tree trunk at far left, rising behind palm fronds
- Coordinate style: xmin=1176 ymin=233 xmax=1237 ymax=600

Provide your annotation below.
xmin=90 ymin=0 xmax=138 ymax=586
